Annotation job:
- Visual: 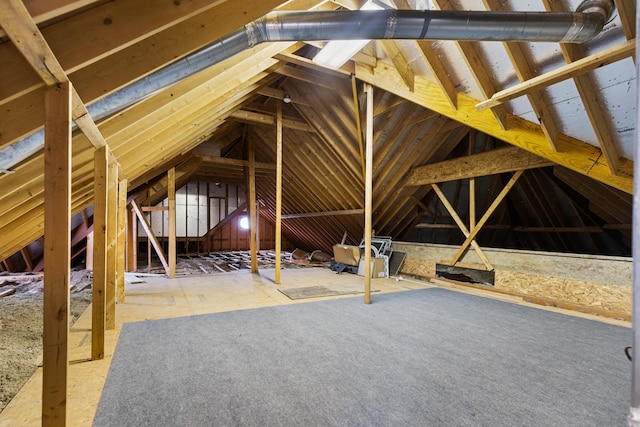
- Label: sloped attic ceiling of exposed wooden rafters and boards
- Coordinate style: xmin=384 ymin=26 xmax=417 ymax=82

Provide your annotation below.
xmin=0 ymin=0 xmax=636 ymax=260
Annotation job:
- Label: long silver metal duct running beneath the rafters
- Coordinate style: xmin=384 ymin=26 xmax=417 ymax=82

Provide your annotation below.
xmin=0 ymin=0 xmax=614 ymax=173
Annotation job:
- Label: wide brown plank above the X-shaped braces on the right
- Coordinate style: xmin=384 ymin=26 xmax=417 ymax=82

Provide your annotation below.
xmin=405 ymin=147 xmax=553 ymax=186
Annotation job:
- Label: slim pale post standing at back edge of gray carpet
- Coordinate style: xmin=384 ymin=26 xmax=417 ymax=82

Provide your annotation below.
xmin=364 ymin=84 xmax=373 ymax=304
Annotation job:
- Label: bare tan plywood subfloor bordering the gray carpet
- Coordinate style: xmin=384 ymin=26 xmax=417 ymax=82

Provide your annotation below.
xmin=0 ymin=268 xmax=629 ymax=427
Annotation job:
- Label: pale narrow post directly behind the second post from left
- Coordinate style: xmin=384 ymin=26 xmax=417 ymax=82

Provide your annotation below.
xmin=105 ymin=157 xmax=118 ymax=330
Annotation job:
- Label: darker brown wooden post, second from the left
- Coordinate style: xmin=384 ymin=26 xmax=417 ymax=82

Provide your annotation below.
xmin=91 ymin=147 xmax=109 ymax=360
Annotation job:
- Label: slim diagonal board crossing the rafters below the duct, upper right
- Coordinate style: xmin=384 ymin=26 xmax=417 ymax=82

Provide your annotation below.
xmin=476 ymin=39 xmax=636 ymax=111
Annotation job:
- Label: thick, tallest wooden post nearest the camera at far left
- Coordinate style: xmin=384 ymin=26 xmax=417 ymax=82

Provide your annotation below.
xmin=42 ymin=82 xmax=72 ymax=426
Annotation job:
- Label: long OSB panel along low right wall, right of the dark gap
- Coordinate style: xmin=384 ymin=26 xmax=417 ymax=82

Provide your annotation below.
xmin=495 ymin=270 xmax=631 ymax=314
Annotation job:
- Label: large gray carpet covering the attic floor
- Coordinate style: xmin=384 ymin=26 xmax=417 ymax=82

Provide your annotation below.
xmin=94 ymin=288 xmax=631 ymax=427
